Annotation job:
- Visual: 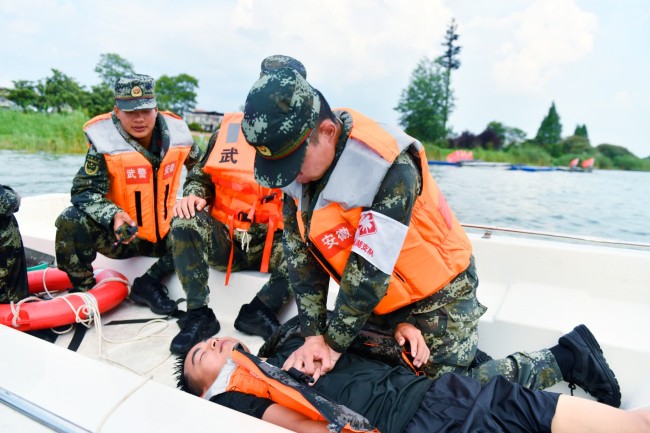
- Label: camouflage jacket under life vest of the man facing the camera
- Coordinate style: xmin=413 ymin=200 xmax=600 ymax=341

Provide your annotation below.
xmin=70 ymin=113 xmax=203 ymax=230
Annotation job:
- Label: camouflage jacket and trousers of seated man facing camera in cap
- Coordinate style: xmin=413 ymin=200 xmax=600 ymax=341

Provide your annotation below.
xmin=55 ymin=110 xmax=202 ymax=290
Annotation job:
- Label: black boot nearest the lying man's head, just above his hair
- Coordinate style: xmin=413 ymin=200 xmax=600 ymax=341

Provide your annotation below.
xmin=169 ymin=306 xmax=221 ymax=354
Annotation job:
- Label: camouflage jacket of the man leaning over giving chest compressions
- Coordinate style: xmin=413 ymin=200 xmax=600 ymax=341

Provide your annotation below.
xmin=283 ymin=112 xmax=422 ymax=352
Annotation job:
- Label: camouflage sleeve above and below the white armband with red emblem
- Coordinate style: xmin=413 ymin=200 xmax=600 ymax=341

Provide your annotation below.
xmin=324 ymin=152 xmax=421 ymax=352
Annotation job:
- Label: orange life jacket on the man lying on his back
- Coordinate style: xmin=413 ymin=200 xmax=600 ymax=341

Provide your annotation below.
xmin=225 ymin=350 xmax=378 ymax=432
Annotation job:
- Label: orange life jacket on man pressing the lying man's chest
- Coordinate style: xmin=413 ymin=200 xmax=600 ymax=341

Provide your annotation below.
xmin=284 ymin=108 xmax=472 ymax=314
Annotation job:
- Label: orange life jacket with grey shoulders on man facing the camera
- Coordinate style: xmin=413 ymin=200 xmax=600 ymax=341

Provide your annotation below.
xmin=84 ymin=112 xmax=194 ymax=242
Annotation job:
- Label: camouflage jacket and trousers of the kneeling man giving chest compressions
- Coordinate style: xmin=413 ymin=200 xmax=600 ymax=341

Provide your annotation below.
xmin=283 ymin=112 xmax=562 ymax=389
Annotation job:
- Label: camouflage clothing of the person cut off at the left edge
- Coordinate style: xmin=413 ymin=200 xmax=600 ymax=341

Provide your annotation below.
xmin=0 ymin=185 xmax=29 ymax=303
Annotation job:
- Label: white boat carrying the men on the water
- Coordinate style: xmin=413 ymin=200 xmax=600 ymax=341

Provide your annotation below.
xmin=0 ymin=194 xmax=650 ymax=432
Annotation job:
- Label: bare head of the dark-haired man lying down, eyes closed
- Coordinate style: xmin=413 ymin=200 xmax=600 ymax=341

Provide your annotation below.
xmin=176 ymin=337 xmax=248 ymax=396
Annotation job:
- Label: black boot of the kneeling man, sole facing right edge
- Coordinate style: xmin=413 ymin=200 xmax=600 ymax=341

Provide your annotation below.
xmin=559 ymin=325 xmax=621 ymax=407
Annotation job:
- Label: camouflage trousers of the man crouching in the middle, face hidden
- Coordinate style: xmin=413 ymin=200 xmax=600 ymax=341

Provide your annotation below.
xmin=171 ymin=212 xmax=292 ymax=313
